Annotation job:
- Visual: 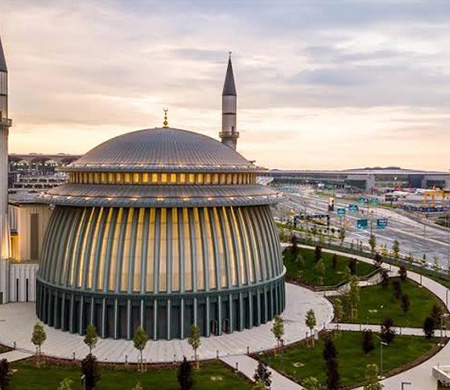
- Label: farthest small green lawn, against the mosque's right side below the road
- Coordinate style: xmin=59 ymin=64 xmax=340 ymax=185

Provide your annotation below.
xmin=284 ymin=248 xmax=375 ymax=287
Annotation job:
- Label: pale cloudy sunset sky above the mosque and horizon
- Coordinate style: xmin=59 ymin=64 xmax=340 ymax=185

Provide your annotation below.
xmin=0 ymin=0 xmax=450 ymax=171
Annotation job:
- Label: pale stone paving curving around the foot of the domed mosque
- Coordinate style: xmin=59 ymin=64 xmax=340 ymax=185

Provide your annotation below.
xmin=0 ymin=283 xmax=333 ymax=362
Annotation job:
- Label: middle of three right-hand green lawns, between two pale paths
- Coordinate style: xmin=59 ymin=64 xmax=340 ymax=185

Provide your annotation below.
xmin=332 ymin=278 xmax=443 ymax=328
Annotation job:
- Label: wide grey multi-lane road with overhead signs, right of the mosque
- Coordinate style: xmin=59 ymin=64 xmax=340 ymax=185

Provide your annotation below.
xmin=276 ymin=187 xmax=450 ymax=269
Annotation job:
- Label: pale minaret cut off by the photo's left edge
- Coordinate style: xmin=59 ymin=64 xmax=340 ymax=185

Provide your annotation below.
xmin=0 ymin=32 xmax=11 ymax=266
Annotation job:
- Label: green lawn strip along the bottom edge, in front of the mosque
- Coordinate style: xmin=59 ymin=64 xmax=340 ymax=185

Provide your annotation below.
xmin=9 ymin=361 xmax=252 ymax=390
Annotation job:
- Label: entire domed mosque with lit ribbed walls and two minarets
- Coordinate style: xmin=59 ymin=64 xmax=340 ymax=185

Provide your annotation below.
xmin=0 ymin=32 xmax=286 ymax=340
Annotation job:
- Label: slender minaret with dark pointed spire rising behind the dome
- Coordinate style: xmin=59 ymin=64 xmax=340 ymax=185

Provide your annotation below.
xmin=219 ymin=52 xmax=239 ymax=150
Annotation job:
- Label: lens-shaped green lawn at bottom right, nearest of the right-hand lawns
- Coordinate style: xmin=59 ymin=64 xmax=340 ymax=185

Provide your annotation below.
xmin=259 ymin=332 xmax=437 ymax=386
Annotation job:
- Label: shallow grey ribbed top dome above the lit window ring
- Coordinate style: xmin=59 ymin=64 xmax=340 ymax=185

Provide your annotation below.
xmin=69 ymin=128 xmax=255 ymax=171
